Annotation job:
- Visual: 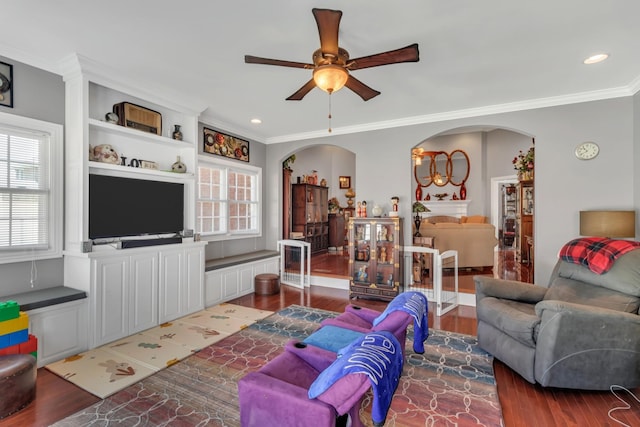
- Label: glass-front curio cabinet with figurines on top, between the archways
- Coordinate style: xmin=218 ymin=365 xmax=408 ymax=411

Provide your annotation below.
xmin=349 ymin=218 xmax=403 ymax=301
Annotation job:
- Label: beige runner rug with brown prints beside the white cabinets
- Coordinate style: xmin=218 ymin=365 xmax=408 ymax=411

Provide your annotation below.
xmin=46 ymin=304 xmax=273 ymax=399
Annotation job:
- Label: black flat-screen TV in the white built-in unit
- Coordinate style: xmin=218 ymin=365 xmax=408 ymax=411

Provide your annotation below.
xmin=89 ymin=174 xmax=184 ymax=239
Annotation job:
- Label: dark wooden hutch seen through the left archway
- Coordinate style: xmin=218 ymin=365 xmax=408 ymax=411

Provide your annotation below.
xmin=291 ymin=184 xmax=329 ymax=253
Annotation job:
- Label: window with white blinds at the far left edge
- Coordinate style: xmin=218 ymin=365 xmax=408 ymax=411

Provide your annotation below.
xmin=0 ymin=116 xmax=62 ymax=262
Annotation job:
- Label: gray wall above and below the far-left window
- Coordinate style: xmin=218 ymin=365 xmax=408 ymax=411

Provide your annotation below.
xmin=0 ymin=56 xmax=64 ymax=299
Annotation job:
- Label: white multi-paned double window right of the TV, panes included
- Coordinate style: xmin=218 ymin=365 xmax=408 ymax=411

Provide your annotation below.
xmin=196 ymin=157 xmax=262 ymax=237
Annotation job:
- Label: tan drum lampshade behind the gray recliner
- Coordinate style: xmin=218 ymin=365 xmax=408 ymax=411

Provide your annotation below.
xmin=580 ymin=211 xmax=636 ymax=239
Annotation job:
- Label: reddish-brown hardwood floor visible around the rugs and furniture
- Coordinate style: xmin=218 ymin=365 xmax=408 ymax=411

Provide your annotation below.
xmin=0 ymin=249 xmax=640 ymax=427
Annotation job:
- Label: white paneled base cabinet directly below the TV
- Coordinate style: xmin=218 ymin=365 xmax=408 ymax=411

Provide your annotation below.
xmin=64 ymin=242 xmax=206 ymax=348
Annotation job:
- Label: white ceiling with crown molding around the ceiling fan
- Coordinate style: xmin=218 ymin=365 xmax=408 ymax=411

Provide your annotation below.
xmin=0 ymin=0 xmax=640 ymax=143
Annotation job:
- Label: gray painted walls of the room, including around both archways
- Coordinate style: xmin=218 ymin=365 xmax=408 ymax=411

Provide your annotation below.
xmin=0 ymin=50 xmax=640 ymax=295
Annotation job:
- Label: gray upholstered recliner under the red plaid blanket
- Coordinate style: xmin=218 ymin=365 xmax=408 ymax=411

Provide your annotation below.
xmin=474 ymin=249 xmax=640 ymax=390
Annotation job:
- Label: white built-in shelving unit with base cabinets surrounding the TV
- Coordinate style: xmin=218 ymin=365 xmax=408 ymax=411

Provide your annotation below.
xmin=61 ymin=55 xmax=206 ymax=347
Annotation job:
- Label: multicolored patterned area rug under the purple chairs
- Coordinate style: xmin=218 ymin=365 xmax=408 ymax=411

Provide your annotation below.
xmin=54 ymin=305 xmax=504 ymax=427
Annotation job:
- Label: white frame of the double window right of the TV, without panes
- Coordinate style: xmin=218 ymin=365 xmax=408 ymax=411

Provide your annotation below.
xmin=195 ymin=155 xmax=262 ymax=241
